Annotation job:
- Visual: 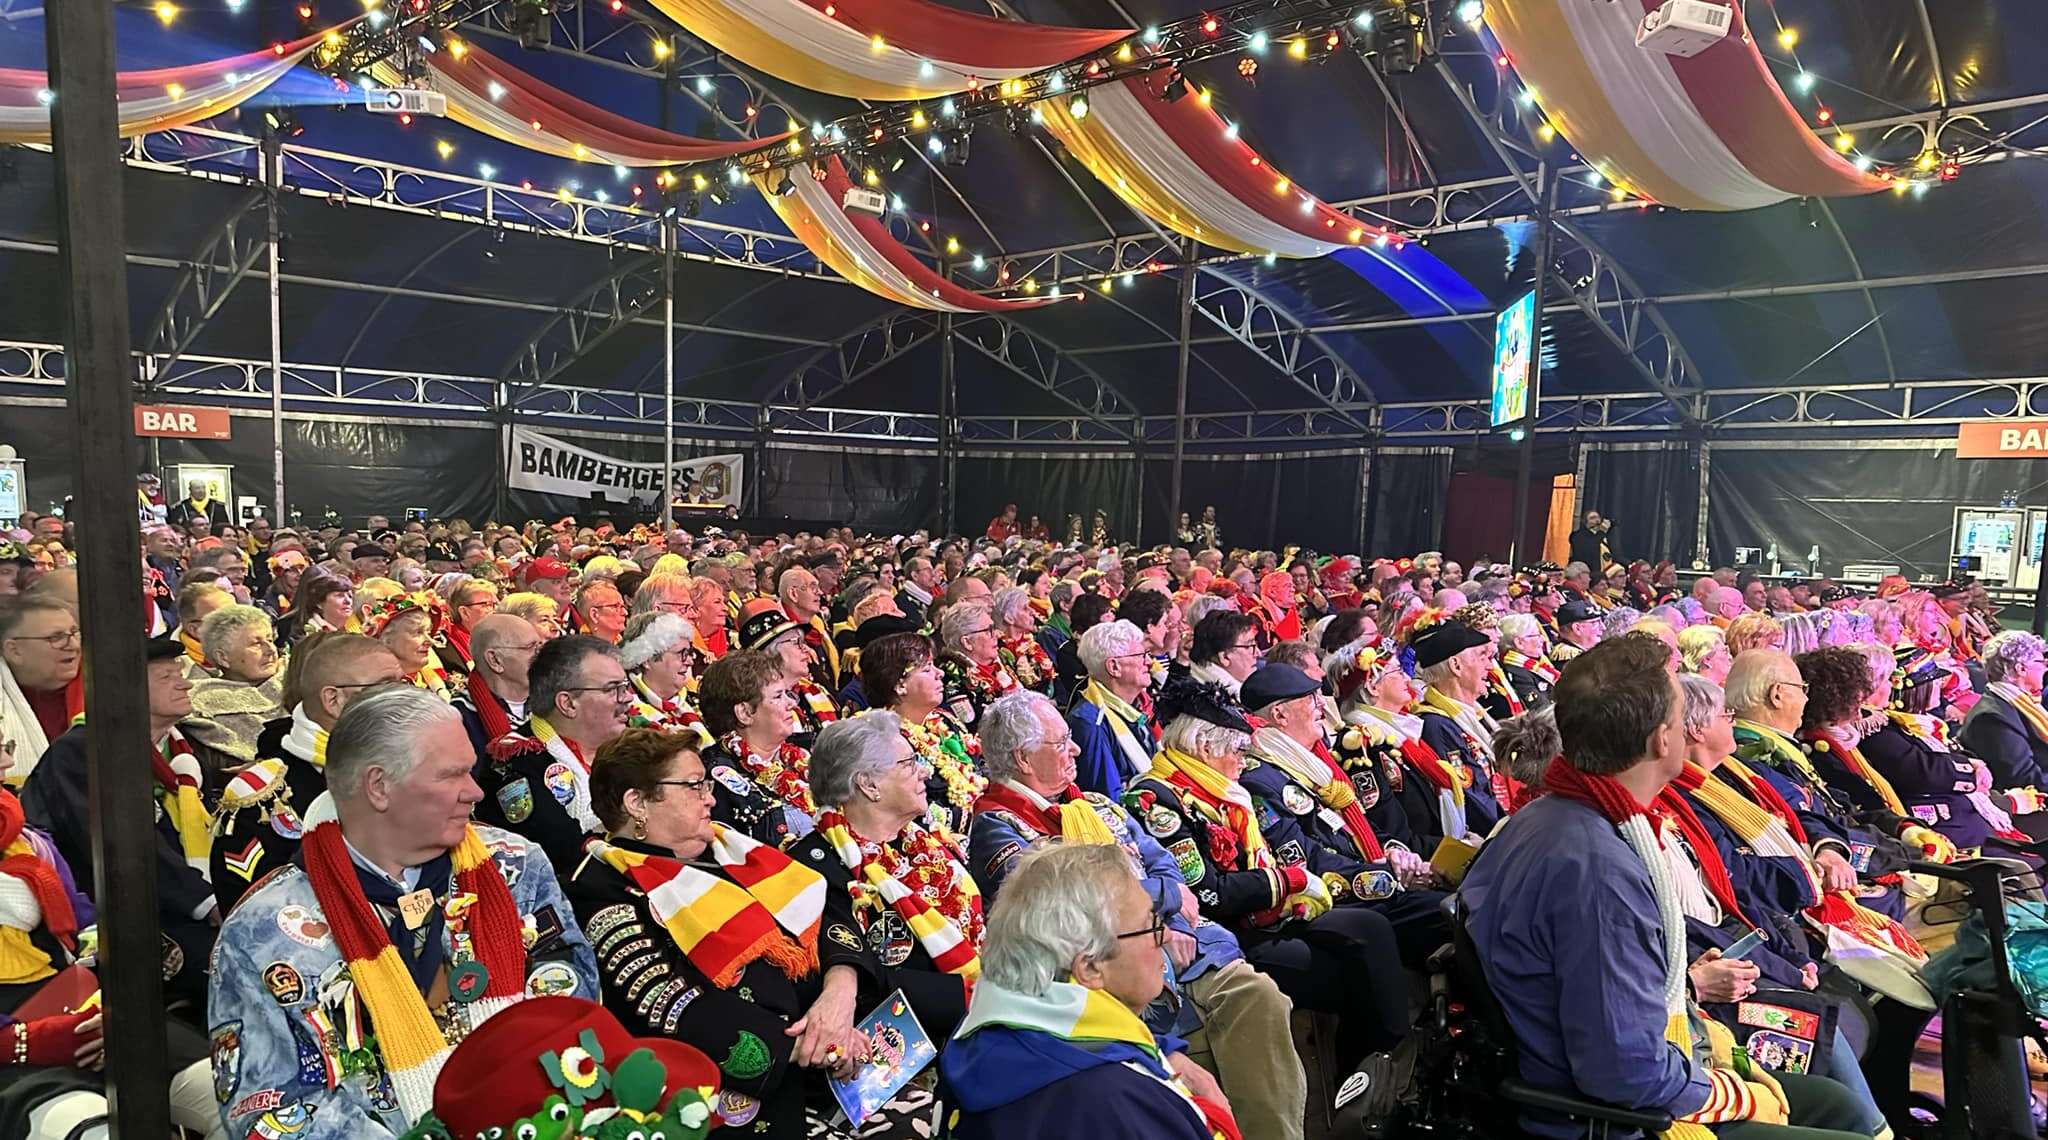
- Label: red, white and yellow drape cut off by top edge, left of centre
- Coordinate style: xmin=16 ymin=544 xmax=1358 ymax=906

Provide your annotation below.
xmin=638 ymin=0 xmax=1130 ymax=100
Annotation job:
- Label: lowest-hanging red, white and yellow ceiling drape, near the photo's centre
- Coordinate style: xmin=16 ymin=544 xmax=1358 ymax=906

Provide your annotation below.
xmin=754 ymin=158 xmax=1059 ymax=313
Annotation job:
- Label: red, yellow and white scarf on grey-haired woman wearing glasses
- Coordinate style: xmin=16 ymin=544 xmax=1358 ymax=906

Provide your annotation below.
xmin=817 ymin=808 xmax=983 ymax=984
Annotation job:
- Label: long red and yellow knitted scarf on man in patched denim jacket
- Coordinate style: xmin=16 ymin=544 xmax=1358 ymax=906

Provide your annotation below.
xmin=299 ymin=819 xmax=526 ymax=1120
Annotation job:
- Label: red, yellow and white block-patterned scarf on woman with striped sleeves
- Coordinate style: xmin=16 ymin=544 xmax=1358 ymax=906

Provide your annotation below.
xmin=586 ymin=823 xmax=825 ymax=989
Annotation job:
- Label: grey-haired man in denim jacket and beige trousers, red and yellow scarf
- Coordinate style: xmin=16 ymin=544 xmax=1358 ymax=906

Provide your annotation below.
xmin=967 ymin=692 xmax=1307 ymax=1138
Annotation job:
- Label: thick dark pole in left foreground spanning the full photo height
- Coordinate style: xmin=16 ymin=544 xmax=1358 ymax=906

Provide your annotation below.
xmin=43 ymin=0 xmax=170 ymax=1140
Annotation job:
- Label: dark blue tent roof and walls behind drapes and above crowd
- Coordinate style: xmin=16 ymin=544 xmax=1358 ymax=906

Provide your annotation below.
xmin=0 ymin=0 xmax=2048 ymax=575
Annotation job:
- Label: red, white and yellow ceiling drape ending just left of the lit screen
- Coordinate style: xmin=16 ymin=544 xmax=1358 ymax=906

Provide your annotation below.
xmin=1036 ymin=72 xmax=1399 ymax=258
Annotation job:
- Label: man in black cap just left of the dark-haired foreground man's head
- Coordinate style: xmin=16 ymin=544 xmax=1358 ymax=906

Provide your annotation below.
xmin=1409 ymin=620 xmax=1511 ymax=835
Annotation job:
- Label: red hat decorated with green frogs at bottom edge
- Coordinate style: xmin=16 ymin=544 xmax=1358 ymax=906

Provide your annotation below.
xmin=434 ymin=997 xmax=719 ymax=1140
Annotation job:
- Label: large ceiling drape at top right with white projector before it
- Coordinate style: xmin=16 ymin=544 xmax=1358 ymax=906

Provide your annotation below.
xmin=1487 ymin=0 xmax=1886 ymax=211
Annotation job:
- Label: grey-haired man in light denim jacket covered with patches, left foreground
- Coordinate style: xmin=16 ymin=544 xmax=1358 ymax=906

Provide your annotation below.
xmin=207 ymin=686 xmax=598 ymax=1140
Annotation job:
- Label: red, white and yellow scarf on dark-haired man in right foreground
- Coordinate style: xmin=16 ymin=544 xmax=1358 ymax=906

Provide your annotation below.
xmin=1542 ymin=757 xmax=1782 ymax=1140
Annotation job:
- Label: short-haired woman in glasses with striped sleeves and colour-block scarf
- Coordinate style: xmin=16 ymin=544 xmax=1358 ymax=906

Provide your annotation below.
xmin=581 ymin=728 xmax=925 ymax=1136
